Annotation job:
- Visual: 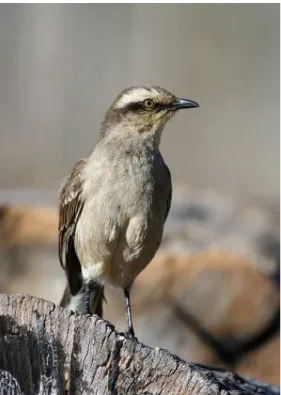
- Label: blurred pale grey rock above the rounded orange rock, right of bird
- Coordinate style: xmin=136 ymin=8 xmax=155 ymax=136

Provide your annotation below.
xmin=162 ymin=185 xmax=280 ymax=274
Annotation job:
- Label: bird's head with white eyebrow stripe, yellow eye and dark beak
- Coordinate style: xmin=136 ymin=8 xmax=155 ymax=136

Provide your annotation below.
xmin=102 ymin=86 xmax=199 ymax=141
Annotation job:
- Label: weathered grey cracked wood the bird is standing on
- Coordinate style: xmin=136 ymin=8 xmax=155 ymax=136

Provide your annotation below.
xmin=0 ymin=294 xmax=280 ymax=395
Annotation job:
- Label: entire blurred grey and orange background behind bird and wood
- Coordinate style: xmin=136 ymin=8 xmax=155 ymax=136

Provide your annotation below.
xmin=0 ymin=4 xmax=280 ymax=383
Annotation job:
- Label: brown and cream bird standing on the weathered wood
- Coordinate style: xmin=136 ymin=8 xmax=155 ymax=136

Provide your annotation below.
xmin=59 ymin=85 xmax=199 ymax=338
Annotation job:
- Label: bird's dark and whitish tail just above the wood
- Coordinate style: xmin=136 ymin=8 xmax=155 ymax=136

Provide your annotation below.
xmin=60 ymin=283 xmax=105 ymax=317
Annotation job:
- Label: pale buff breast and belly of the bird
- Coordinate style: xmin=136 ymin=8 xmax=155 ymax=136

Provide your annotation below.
xmin=76 ymin=145 xmax=168 ymax=286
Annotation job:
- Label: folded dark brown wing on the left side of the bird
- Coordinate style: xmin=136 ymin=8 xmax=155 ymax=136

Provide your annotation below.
xmin=59 ymin=159 xmax=85 ymax=295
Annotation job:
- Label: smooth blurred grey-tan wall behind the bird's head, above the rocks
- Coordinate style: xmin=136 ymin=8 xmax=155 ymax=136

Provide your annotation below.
xmin=0 ymin=4 xmax=280 ymax=198
